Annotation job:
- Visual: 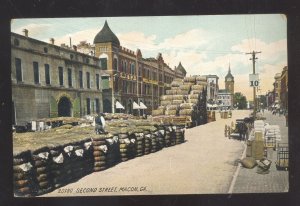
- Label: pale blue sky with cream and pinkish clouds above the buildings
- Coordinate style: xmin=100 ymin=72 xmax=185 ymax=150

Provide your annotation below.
xmin=11 ymin=14 xmax=287 ymax=100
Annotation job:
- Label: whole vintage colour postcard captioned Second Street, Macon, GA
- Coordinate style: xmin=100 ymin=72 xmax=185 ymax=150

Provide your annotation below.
xmin=11 ymin=14 xmax=289 ymax=197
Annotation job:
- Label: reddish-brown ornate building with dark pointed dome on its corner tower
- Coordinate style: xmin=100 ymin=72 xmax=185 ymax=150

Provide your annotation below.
xmin=94 ymin=22 xmax=186 ymax=113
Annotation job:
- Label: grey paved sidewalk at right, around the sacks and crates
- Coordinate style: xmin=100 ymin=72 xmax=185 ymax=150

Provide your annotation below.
xmin=232 ymin=111 xmax=289 ymax=193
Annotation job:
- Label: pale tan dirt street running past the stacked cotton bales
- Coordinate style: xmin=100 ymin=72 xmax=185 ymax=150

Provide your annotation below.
xmin=43 ymin=111 xmax=249 ymax=196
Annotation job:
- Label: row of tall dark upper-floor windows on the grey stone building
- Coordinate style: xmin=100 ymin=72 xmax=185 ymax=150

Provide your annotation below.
xmin=15 ymin=58 xmax=100 ymax=90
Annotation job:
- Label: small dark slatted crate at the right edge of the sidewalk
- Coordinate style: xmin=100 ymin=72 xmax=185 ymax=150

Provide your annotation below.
xmin=275 ymin=143 xmax=289 ymax=170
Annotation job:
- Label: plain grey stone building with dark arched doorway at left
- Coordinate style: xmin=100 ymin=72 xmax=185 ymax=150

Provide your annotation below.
xmin=11 ymin=30 xmax=103 ymax=125
